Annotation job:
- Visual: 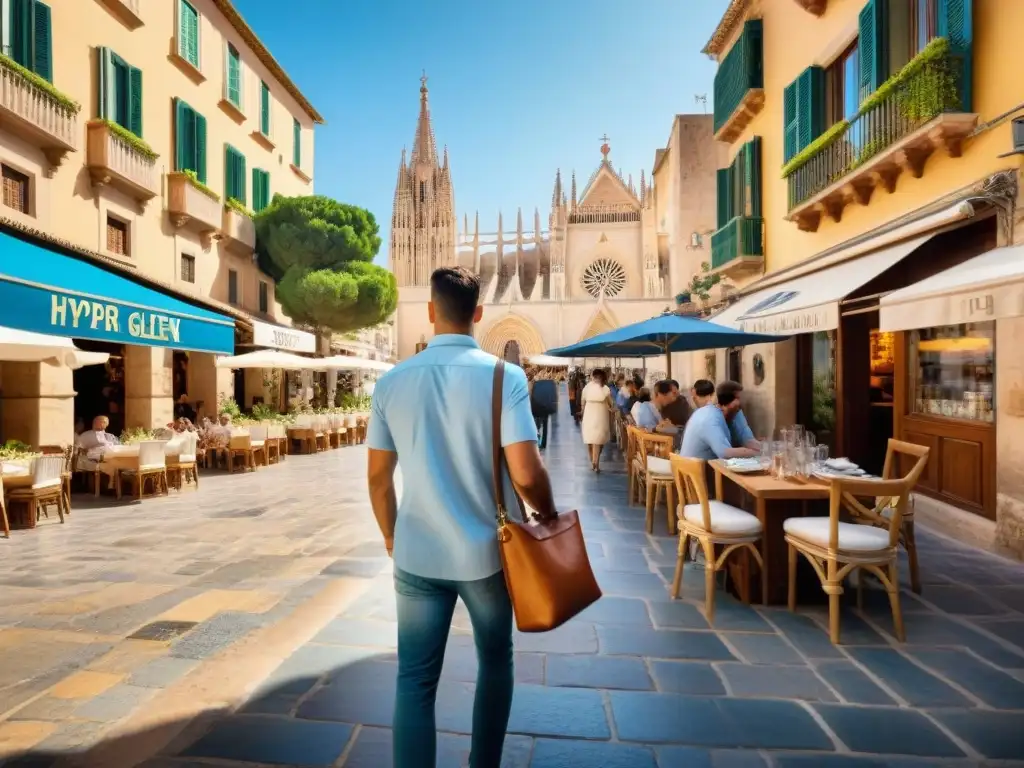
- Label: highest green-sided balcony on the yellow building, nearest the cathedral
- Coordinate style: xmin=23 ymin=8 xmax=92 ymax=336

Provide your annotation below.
xmin=715 ymin=18 xmax=765 ymax=142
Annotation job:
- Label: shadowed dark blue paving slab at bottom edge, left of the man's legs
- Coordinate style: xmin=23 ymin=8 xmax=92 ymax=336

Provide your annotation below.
xmin=184 ymin=716 xmax=352 ymax=766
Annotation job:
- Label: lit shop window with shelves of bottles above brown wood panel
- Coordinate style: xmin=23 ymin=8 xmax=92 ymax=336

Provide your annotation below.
xmin=909 ymin=323 xmax=995 ymax=422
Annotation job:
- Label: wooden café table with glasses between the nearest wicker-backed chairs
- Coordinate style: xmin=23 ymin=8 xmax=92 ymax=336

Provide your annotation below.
xmin=709 ymin=459 xmax=828 ymax=605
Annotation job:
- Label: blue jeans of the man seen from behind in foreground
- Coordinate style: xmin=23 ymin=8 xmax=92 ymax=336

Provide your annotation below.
xmin=394 ymin=568 xmax=513 ymax=768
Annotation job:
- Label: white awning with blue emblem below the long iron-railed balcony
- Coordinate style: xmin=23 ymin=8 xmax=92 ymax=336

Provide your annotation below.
xmin=712 ymin=234 xmax=932 ymax=334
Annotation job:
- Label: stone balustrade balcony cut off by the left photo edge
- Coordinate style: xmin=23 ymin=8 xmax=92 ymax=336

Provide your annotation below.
xmin=0 ymin=55 xmax=80 ymax=178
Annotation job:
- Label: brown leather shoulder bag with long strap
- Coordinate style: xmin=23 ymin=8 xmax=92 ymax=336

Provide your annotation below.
xmin=490 ymin=360 xmax=601 ymax=632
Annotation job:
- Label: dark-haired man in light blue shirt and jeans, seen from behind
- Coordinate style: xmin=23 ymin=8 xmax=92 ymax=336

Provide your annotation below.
xmin=367 ymin=267 xmax=555 ymax=768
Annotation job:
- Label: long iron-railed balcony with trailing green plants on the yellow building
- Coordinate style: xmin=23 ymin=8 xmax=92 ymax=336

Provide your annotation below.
xmin=783 ymin=39 xmax=978 ymax=231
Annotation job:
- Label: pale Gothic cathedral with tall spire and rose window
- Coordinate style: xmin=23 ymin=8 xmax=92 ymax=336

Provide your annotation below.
xmin=390 ymin=77 xmax=673 ymax=362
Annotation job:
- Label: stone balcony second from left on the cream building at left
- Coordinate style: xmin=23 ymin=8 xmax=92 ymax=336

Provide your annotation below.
xmin=86 ymin=120 xmax=160 ymax=209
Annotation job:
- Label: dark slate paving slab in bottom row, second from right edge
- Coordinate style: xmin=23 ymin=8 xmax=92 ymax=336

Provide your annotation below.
xmin=814 ymin=705 xmax=964 ymax=758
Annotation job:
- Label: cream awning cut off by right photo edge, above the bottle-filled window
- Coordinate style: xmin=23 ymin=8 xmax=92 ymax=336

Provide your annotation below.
xmin=880 ymin=245 xmax=1024 ymax=331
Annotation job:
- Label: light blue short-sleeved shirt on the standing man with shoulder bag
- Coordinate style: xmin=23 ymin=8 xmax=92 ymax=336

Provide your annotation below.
xmin=367 ymin=334 xmax=537 ymax=582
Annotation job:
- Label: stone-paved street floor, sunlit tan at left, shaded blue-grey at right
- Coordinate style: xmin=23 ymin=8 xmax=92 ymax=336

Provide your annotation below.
xmin=0 ymin=411 xmax=1024 ymax=768
